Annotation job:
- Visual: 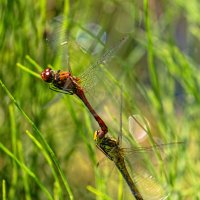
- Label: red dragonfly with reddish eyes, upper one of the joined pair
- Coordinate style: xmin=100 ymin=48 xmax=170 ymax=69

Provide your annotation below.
xmin=41 ymin=36 xmax=128 ymax=138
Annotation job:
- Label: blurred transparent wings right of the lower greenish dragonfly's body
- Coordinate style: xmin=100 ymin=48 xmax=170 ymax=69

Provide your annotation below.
xmin=122 ymin=115 xmax=184 ymax=200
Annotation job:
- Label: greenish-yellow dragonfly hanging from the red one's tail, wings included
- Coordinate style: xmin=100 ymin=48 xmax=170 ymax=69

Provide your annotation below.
xmin=94 ymin=88 xmax=182 ymax=200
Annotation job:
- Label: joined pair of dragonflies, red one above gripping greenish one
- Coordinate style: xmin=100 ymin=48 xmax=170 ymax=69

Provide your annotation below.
xmin=41 ymin=37 xmax=180 ymax=200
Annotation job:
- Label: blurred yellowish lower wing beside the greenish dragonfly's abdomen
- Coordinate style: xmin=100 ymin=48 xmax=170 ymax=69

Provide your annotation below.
xmin=124 ymin=144 xmax=180 ymax=200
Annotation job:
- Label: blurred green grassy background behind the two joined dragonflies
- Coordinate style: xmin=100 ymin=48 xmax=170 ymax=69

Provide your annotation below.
xmin=0 ymin=0 xmax=200 ymax=200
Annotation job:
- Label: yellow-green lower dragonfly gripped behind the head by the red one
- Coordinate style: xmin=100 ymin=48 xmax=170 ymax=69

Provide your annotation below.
xmin=94 ymin=115 xmax=182 ymax=200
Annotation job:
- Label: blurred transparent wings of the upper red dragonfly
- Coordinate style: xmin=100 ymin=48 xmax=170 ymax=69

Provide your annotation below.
xmin=45 ymin=16 xmax=128 ymax=91
